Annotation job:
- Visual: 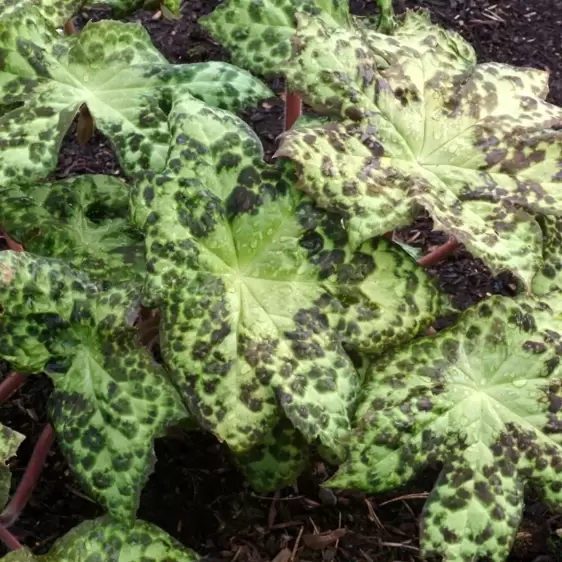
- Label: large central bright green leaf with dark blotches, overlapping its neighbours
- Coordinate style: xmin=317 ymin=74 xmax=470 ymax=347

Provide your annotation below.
xmin=133 ymin=94 xmax=441 ymax=453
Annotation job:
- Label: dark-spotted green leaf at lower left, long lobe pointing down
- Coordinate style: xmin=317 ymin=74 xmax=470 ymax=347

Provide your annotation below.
xmin=0 ymin=251 xmax=187 ymax=523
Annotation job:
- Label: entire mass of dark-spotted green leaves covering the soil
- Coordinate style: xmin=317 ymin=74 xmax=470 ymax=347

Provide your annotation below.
xmin=0 ymin=0 xmax=562 ymax=562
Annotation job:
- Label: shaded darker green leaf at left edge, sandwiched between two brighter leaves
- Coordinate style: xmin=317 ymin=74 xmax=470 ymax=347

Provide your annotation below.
xmin=0 ymin=175 xmax=145 ymax=283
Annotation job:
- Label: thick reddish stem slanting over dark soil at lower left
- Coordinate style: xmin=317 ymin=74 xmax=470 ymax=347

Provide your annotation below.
xmin=0 ymin=423 xmax=55 ymax=528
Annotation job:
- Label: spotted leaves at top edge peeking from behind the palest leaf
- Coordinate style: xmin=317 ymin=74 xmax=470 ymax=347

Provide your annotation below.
xmin=199 ymin=0 xmax=475 ymax=76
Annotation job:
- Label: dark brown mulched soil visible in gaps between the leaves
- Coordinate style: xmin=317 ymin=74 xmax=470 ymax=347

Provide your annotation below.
xmin=0 ymin=0 xmax=562 ymax=562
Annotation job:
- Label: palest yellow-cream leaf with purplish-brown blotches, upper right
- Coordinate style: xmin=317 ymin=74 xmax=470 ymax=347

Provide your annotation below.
xmin=277 ymin=14 xmax=562 ymax=288
